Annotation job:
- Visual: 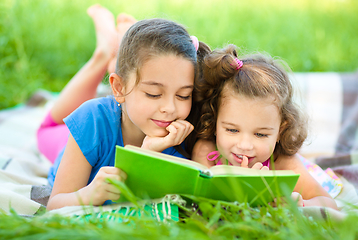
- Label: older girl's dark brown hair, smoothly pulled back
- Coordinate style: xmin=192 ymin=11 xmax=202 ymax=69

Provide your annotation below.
xmin=115 ymin=18 xmax=210 ymax=158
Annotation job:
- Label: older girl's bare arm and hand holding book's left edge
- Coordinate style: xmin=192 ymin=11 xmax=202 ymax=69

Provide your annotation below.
xmin=47 ymin=134 xmax=120 ymax=210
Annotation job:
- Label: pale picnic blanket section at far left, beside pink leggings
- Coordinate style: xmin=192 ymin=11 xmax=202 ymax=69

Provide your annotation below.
xmin=0 ymin=99 xmax=51 ymax=215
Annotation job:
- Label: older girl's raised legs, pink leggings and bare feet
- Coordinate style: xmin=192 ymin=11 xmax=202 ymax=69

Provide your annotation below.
xmin=37 ymin=4 xmax=136 ymax=162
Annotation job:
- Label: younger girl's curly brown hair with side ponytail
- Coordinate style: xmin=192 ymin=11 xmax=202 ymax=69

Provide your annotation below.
xmin=197 ymin=45 xmax=307 ymax=157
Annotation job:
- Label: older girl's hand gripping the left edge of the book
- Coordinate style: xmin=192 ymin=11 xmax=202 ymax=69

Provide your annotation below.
xmin=78 ymin=167 xmax=126 ymax=206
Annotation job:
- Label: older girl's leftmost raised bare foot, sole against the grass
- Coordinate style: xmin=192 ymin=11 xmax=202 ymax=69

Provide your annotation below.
xmin=87 ymin=4 xmax=119 ymax=60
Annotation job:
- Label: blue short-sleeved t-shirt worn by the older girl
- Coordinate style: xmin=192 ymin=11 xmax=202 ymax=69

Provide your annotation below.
xmin=48 ymin=96 xmax=184 ymax=186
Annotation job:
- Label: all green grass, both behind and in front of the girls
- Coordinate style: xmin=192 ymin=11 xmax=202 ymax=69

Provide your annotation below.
xmin=0 ymin=0 xmax=358 ymax=240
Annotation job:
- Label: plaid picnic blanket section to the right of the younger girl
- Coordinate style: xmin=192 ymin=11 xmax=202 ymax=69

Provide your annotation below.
xmin=293 ymin=72 xmax=358 ymax=204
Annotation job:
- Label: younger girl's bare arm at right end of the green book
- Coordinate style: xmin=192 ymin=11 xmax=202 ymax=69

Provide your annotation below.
xmin=275 ymin=155 xmax=338 ymax=209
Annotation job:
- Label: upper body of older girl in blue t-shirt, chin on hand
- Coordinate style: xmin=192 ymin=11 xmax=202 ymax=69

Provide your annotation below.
xmin=42 ymin=6 xmax=210 ymax=209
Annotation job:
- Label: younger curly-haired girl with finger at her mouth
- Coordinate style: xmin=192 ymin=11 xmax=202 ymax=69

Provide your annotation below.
xmin=193 ymin=45 xmax=337 ymax=209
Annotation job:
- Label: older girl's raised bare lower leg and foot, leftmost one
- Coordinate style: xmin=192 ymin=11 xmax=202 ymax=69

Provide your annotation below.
xmin=51 ymin=4 xmax=119 ymax=124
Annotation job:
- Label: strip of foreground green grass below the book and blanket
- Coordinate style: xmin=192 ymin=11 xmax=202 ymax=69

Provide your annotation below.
xmin=0 ymin=196 xmax=358 ymax=240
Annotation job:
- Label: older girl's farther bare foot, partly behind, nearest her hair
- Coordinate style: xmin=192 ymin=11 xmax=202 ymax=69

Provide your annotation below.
xmin=107 ymin=13 xmax=137 ymax=73
